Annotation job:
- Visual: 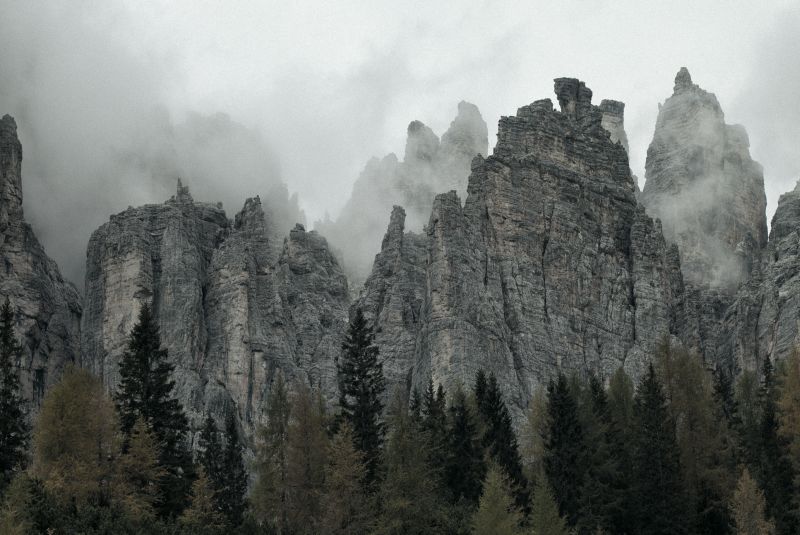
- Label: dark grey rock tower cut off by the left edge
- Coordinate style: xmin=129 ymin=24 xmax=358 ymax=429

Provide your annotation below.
xmin=0 ymin=115 xmax=81 ymax=409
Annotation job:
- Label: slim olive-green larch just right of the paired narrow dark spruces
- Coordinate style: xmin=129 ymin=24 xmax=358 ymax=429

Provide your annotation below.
xmin=251 ymin=372 xmax=290 ymax=533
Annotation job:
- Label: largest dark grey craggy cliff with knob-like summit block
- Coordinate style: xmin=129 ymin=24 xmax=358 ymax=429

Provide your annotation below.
xmin=358 ymin=78 xmax=685 ymax=416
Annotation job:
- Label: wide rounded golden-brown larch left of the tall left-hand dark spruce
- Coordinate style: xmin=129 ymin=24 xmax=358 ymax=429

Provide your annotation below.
xmin=33 ymin=367 xmax=120 ymax=505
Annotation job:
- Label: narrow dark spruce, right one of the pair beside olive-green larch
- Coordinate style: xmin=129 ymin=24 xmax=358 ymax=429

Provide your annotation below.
xmin=217 ymin=412 xmax=247 ymax=527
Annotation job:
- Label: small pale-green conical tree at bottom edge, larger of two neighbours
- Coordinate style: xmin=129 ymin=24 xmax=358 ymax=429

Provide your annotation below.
xmin=472 ymin=464 xmax=523 ymax=535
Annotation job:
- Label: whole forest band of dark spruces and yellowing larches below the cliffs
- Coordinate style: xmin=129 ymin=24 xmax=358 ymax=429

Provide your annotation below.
xmin=0 ymin=302 xmax=800 ymax=535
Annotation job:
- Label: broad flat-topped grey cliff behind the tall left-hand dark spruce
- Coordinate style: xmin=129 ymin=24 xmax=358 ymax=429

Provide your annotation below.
xmin=82 ymin=184 xmax=348 ymax=442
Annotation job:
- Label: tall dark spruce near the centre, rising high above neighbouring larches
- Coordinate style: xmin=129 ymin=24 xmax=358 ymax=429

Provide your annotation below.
xmin=337 ymin=308 xmax=385 ymax=486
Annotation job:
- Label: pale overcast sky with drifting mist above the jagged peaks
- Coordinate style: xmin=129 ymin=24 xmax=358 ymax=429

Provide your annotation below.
xmin=0 ymin=0 xmax=800 ymax=284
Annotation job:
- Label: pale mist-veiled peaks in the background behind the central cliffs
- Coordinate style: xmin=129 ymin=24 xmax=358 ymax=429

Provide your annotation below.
xmin=315 ymin=102 xmax=489 ymax=285
